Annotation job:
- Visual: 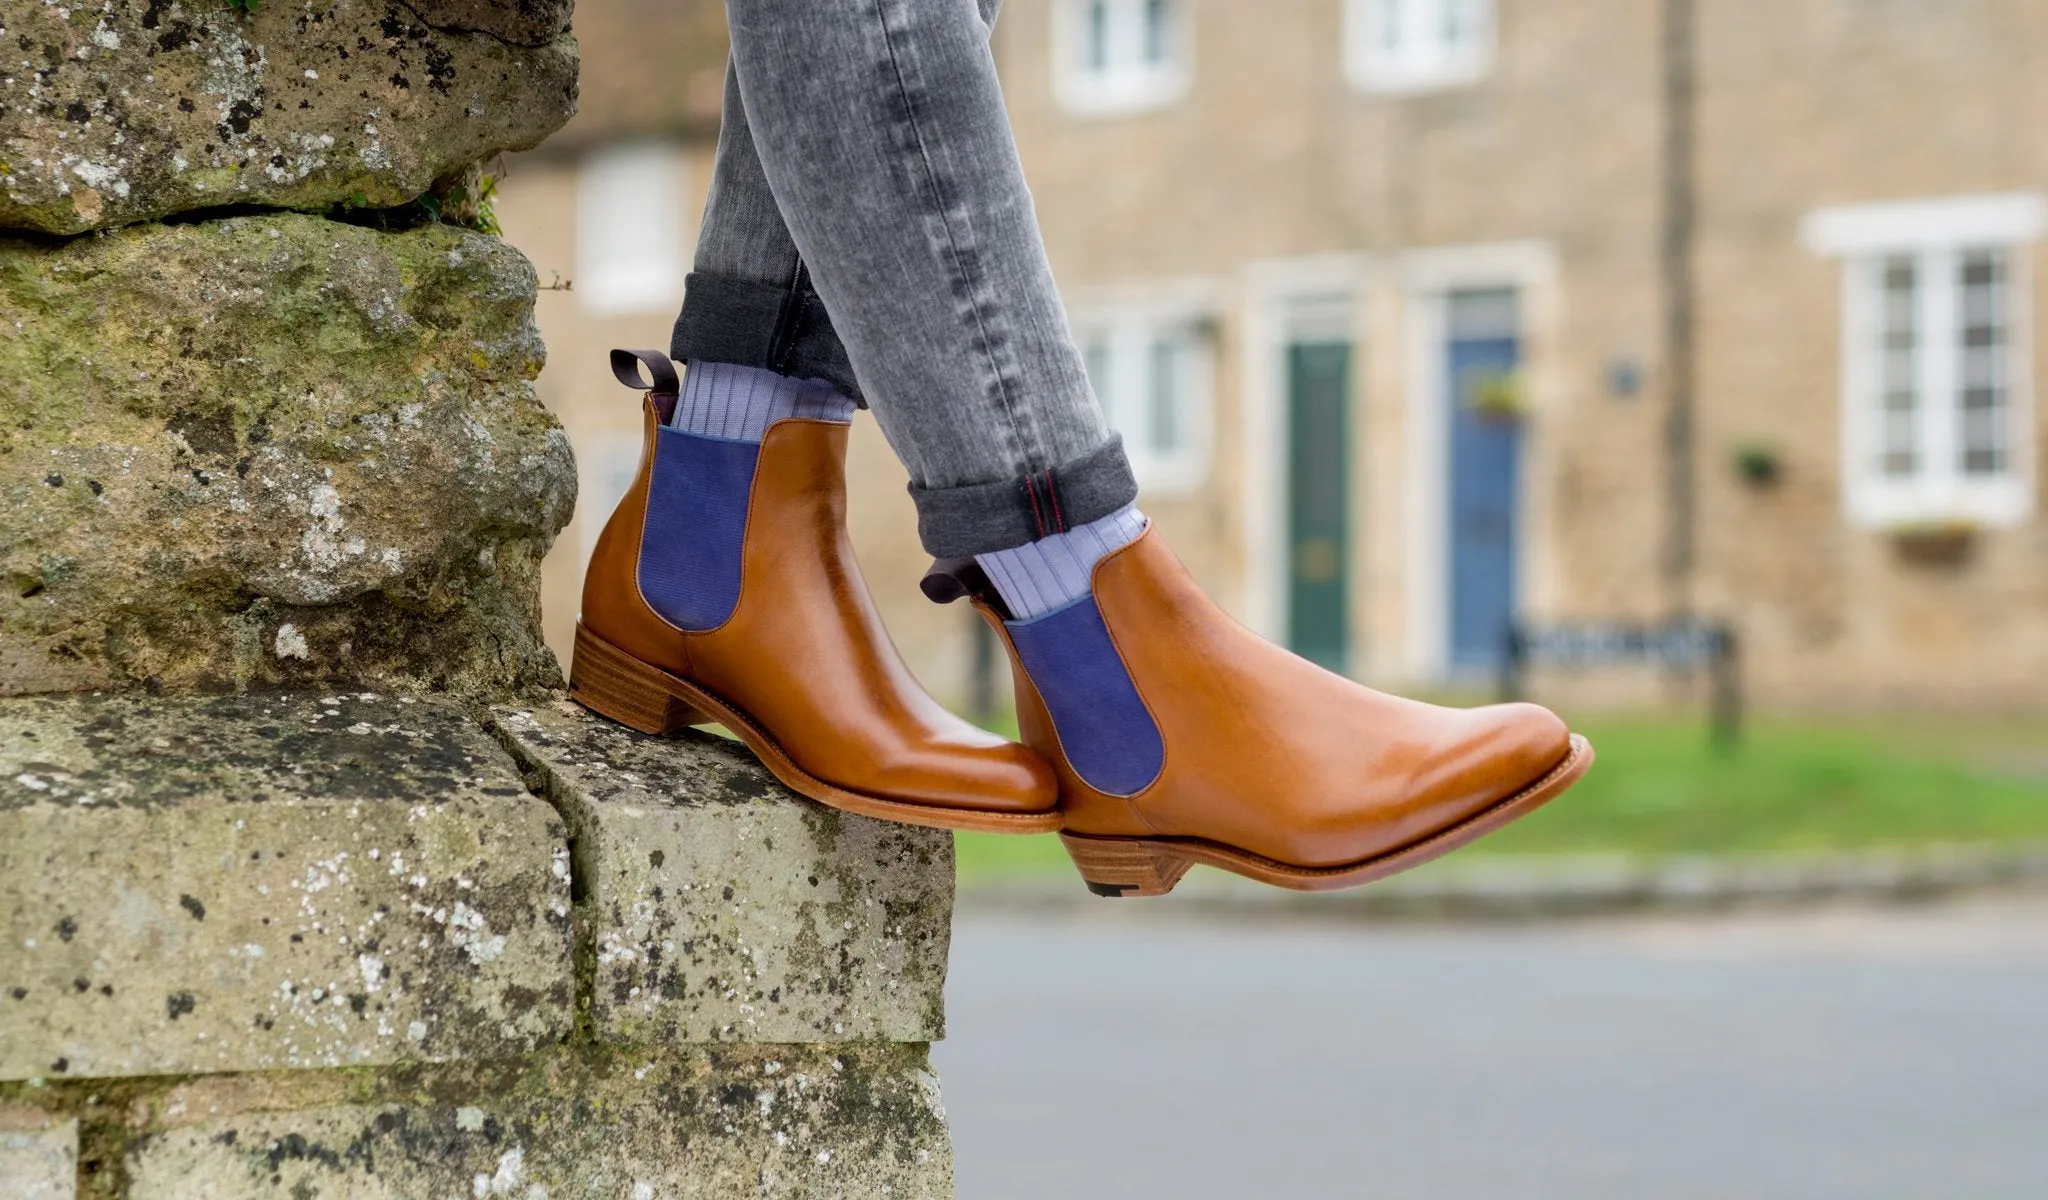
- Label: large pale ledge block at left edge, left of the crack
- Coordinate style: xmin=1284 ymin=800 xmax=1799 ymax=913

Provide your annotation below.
xmin=0 ymin=694 xmax=573 ymax=1079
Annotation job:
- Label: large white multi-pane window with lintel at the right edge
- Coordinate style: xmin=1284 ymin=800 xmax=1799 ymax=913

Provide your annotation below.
xmin=1804 ymin=195 xmax=2048 ymax=528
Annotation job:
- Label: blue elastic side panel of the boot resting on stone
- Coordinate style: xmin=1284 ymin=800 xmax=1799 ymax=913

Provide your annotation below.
xmin=639 ymin=428 xmax=760 ymax=631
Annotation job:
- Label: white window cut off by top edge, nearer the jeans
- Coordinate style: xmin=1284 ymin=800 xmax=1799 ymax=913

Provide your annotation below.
xmin=1053 ymin=0 xmax=1192 ymax=117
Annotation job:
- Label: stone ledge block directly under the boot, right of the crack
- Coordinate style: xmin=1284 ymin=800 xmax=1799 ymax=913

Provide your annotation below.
xmin=496 ymin=702 xmax=952 ymax=1042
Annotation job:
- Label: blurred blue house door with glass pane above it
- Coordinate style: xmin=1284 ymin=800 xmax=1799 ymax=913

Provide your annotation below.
xmin=1446 ymin=291 xmax=1522 ymax=674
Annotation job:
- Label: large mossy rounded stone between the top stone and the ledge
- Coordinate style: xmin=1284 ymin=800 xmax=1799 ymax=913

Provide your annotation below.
xmin=0 ymin=213 xmax=575 ymax=694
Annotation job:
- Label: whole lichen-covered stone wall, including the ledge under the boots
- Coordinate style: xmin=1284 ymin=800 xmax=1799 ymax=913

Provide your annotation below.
xmin=0 ymin=0 xmax=952 ymax=1200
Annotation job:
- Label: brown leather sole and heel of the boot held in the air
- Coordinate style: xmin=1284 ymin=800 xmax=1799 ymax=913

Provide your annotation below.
xmin=1059 ymin=733 xmax=1593 ymax=897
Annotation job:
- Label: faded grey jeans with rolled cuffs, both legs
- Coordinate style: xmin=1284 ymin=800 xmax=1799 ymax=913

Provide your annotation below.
xmin=672 ymin=0 xmax=1137 ymax=557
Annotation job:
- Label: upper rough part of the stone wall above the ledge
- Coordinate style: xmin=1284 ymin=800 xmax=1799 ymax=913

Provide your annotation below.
xmin=0 ymin=0 xmax=575 ymax=694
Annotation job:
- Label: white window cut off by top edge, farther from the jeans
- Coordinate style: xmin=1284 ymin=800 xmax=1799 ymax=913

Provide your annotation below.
xmin=1343 ymin=0 xmax=1495 ymax=92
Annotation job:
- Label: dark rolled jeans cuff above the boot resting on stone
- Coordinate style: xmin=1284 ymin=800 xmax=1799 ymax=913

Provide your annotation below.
xmin=668 ymin=270 xmax=866 ymax=408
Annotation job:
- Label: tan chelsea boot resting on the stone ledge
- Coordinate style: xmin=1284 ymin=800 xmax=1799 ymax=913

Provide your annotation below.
xmin=569 ymin=350 xmax=1059 ymax=833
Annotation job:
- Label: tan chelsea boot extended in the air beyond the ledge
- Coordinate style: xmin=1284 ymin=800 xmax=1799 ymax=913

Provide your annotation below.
xmin=926 ymin=530 xmax=1593 ymax=895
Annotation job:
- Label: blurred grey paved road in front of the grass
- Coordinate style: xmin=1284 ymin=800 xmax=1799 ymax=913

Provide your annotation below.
xmin=934 ymin=897 xmax=2048 ymax=1200
